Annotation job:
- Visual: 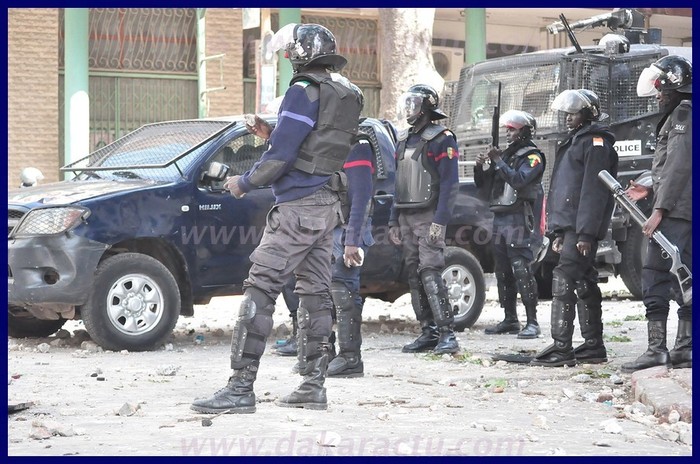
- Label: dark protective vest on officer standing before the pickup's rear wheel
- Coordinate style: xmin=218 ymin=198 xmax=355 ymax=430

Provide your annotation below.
xmin=395 ymin=123 xmax=447 ymax=208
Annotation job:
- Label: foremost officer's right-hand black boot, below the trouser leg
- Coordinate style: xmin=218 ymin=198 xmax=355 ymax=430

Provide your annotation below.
xmin=275 ymin=349 xmax=328 ymax=410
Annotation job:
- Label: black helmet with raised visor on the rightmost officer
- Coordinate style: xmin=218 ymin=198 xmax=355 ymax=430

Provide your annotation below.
xmin=637 ymin=55 xmax=693 ymax=97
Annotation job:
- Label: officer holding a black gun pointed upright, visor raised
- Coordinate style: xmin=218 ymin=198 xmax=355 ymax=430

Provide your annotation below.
xmin=474 ymin=110 xmax=546 ymax=338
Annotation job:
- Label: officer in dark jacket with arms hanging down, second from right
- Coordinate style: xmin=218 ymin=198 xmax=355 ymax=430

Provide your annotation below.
xmin=531 ymin=89 xmax=617 ymax=367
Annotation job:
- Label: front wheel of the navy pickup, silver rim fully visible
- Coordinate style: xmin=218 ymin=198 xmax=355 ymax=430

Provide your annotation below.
xmin=81 ymin=253 xmax=180 ymax=351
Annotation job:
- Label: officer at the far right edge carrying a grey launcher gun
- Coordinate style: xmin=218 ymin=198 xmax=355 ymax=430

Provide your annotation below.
xmin=622 ymin=55 xmax=693 ymax=372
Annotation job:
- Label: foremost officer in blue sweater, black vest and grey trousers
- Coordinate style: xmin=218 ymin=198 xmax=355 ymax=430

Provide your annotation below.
xmin=192 ymin=24 xmax=361 ymax=413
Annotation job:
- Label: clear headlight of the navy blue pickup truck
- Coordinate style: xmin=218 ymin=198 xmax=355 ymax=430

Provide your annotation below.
xmin=10 ymin=206 xmax=90 ymax=238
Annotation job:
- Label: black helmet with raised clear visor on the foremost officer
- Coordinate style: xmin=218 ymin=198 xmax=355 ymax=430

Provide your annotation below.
xmin=268 ymin=23 xmax=348 ymax=73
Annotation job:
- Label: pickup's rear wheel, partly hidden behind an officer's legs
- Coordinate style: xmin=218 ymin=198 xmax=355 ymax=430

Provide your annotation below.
xmin=442 ymin=247 xmax=486 ymax=331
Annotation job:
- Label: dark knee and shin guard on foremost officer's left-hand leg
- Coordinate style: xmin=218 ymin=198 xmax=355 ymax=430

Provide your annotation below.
xmin=231 ymin=290 xmax=275 ymax=369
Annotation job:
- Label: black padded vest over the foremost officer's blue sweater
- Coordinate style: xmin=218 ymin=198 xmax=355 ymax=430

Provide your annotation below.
xmin=290 ymin=73 xmax=362 ymax=176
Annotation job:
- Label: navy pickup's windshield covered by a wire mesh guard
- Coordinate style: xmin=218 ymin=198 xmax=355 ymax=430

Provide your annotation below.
xmin=61 ymin=120 xmax=233 ymax=182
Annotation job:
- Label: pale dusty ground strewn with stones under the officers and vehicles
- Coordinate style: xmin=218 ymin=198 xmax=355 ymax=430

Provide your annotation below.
xmin=8 ymin=276 xmax=692 ymax=456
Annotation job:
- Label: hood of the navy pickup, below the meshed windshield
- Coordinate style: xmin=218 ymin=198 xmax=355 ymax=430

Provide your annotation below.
xmin=7 ymin=180 xmax=156 ymax=205
